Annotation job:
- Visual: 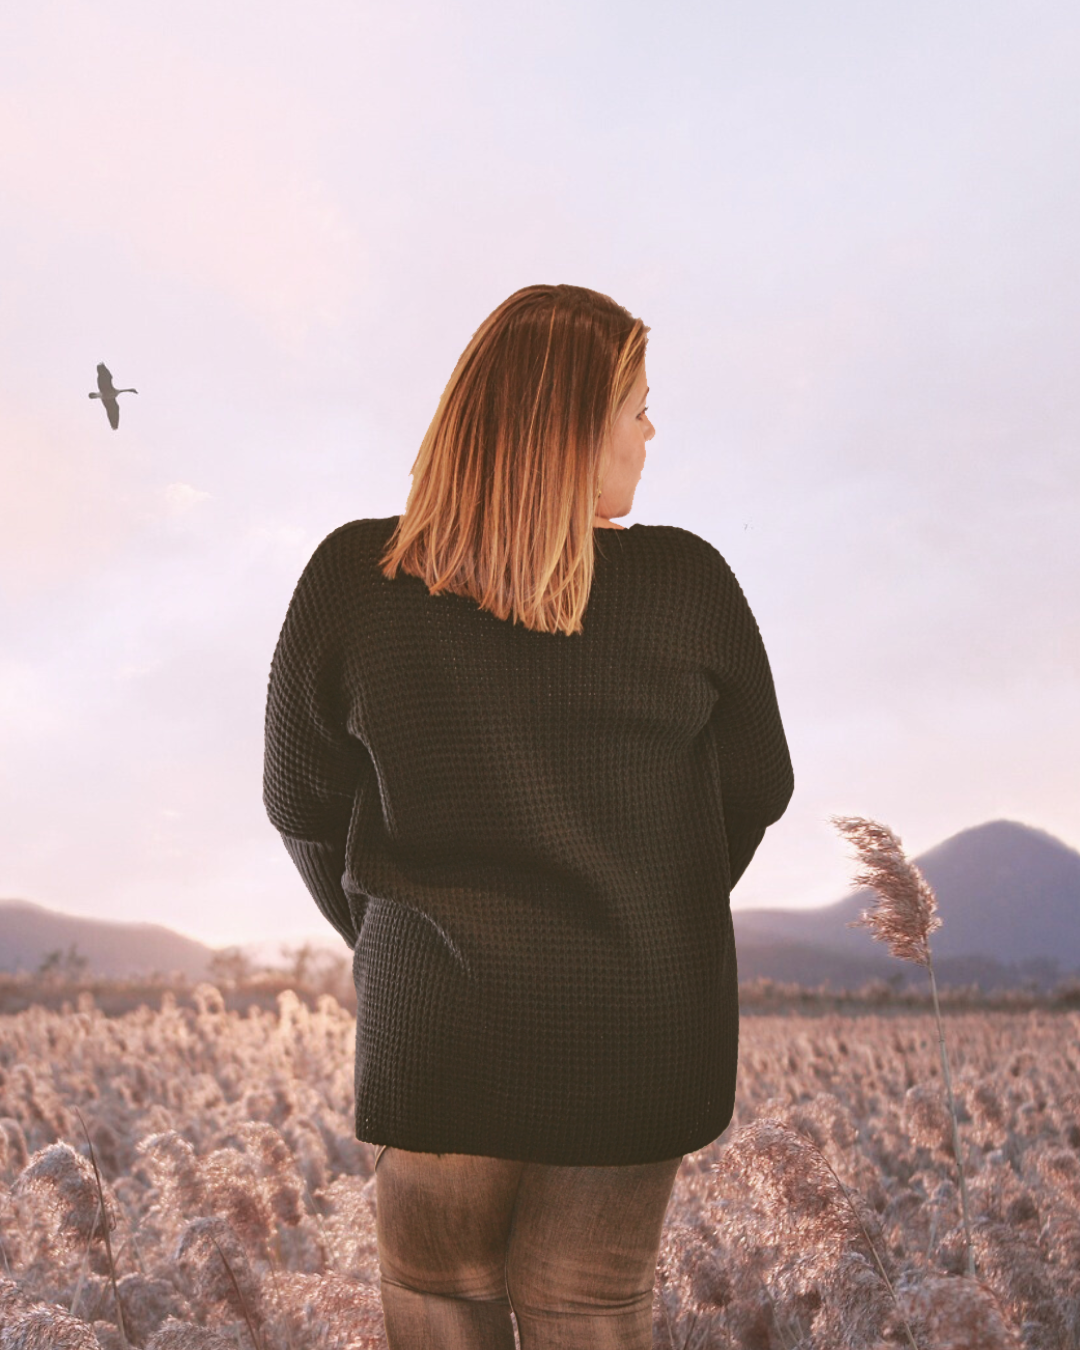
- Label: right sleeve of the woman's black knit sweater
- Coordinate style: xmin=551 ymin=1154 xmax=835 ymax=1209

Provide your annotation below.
xmin=710 ymin=549 xmax=794 ymax=887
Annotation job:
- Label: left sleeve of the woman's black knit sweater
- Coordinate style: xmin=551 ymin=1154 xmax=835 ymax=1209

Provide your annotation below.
xmin=263 ymin=541 xmax=367 ymax=946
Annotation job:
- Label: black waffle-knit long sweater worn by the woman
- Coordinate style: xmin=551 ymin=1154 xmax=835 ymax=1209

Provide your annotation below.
xmin=263 ymin=517 xmax=792 ymax=1165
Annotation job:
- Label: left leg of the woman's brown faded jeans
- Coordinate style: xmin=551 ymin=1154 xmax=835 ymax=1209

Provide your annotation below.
xmin=375 ymin=1148 xmax=525 ymax=1350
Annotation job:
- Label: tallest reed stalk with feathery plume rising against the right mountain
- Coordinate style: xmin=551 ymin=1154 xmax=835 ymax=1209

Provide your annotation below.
xmin=832 ymin=815 xmax=975 ymax=1278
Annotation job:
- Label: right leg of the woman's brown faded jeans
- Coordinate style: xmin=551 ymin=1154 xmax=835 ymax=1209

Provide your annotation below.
xmin=506 ymin=1158 xmax=682 ymax=1350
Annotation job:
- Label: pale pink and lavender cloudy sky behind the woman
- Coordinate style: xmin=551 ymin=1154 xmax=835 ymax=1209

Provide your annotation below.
xmin=0 ymin=0 xmax=1080 ymax=945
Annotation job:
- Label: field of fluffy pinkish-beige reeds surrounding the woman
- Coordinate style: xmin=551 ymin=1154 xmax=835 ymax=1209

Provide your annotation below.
xmin=0 ymin=984 xmax=1080 ymax=1350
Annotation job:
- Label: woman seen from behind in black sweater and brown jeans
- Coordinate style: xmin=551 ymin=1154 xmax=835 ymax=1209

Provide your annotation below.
xmin=265 ymin=286 xmax=792 ymax=1350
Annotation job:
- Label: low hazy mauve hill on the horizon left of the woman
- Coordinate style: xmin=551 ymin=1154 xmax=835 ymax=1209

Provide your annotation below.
xmin=0 ymin=900 xmax=215 ymax=980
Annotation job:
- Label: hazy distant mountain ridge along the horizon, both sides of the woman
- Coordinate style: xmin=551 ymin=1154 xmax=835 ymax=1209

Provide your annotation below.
xmin=0 ymin=821 xmax=1080 ymax=990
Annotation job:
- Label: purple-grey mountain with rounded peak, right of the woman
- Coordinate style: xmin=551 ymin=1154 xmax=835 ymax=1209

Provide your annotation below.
xmin=732 ymin=821 xmax=1080 ymax=988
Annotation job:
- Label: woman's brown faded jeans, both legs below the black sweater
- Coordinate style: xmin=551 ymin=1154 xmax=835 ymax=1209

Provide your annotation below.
xmin=375 ymin=1148 xmax=682 ymax=1350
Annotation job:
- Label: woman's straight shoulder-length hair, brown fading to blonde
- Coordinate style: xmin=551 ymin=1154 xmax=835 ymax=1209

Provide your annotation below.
xmin=379 ymin=286 xmax=649 ymax=636
